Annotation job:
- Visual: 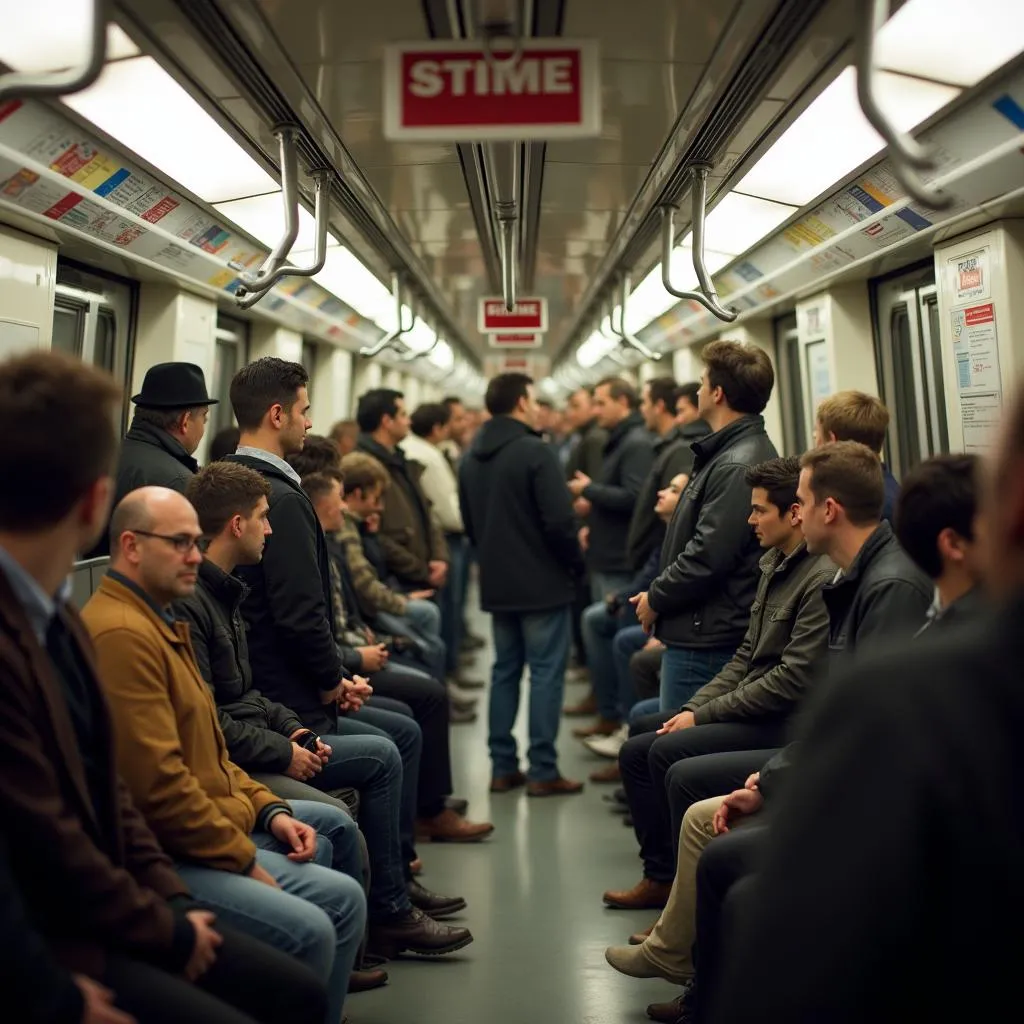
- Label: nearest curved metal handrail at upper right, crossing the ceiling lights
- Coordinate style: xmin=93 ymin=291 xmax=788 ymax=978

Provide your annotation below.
xmin=856 ymin=0 xmax=953 ymax=210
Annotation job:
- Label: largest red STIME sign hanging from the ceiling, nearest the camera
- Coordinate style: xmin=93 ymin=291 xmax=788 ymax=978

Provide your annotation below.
xmin=384 ymin=39 xmax=601 ymax=142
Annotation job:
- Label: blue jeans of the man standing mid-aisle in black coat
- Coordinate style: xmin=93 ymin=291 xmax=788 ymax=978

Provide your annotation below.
xmin=489 ymin=608 xmax=571 ymax=782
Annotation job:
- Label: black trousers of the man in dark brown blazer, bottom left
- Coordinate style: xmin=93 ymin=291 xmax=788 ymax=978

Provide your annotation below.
xmin=101 ymin=924 xmax=327 ymax=1024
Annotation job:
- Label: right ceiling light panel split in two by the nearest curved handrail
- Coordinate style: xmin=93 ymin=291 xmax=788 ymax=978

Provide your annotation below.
xmin=735 ymin=68 xmax=958 ymax=207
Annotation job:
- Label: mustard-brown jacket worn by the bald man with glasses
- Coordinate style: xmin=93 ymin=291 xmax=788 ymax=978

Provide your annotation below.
xmin=82 ymin=575 xmax=282 ymax=872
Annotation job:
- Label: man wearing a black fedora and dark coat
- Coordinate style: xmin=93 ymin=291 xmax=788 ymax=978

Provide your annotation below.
xmin=89 ymin=362 xmax=217 ymax=558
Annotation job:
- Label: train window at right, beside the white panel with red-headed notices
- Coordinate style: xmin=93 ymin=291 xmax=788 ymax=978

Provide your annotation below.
xmin=871 ymin=262 xmax=949 ymax=477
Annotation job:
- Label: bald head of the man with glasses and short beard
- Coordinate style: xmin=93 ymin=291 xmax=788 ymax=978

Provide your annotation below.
xmin=111 ymin=487 xmax=203 ymax=606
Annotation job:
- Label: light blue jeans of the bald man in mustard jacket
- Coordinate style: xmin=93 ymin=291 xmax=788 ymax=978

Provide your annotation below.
xmin=176 ymin=800 xmax=367 ymax=1024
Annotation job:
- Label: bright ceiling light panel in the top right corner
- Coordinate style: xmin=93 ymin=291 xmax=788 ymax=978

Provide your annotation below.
xmin=874 ymin=0 xmax=1024 ymax=87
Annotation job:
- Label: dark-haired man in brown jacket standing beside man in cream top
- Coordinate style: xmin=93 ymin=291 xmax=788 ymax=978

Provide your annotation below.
xmin=355 ymin=388 xmax=449 ymax=590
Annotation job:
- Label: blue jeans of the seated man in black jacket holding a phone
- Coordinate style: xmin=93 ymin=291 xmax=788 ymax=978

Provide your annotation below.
xmin=315 ymin=734 xmax=411 ymax=922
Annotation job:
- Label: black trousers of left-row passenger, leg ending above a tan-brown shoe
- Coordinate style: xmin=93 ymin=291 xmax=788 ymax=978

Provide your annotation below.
xmin=370 ymin=665 xmax=452 ymax=818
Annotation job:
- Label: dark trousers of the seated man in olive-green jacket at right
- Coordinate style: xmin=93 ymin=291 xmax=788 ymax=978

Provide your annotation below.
xmin=618 ymin=722 xmax=783 ymax=884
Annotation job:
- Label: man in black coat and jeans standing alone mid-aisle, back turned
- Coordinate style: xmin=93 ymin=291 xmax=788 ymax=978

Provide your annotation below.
xmin=459 ymin=374 xmax=583 ymax=797
